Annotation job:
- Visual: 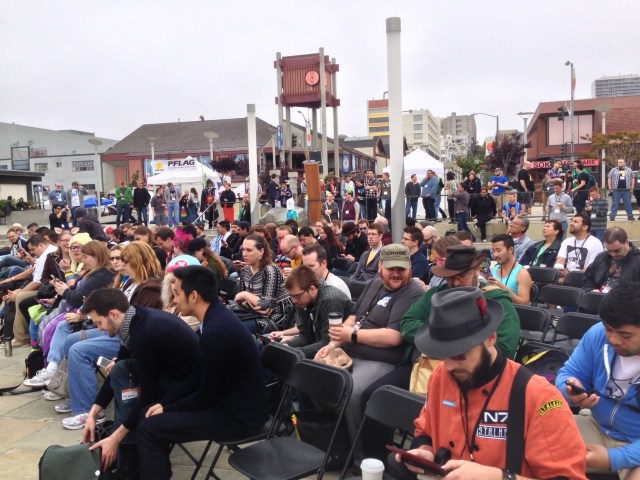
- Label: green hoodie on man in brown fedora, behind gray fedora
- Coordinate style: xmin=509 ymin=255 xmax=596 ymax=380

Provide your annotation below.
xmin=400 ymin=283 xmax=520 ymax=358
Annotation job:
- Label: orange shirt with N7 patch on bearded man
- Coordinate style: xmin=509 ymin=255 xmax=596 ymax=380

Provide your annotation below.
xmin=415 ymin=360 xmax=586 ymax=479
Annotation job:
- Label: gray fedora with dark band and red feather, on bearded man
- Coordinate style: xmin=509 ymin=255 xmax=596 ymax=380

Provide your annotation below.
xmin=414 ymin=287 xmax=504 ymax=358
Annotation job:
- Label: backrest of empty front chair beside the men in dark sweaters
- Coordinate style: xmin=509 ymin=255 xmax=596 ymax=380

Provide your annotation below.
xmin=287 ymin=359 xmax=353 ymax=405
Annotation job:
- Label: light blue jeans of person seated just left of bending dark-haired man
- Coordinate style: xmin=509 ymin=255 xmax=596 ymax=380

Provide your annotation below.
xmin=64 ymin=328 xmax=120 ymax=415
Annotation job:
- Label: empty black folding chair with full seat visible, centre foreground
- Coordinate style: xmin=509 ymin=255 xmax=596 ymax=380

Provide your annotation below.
xmin=229 ymin=359 xmax=353 ymax=480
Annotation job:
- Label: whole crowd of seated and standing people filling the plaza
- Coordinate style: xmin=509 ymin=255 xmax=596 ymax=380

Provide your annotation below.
xmin=0 ymin=162 xmax=640 ymax=480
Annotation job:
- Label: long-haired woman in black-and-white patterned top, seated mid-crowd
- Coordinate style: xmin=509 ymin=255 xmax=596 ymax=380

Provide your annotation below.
xmin=235 ymin=235 xmax=294 ymax=331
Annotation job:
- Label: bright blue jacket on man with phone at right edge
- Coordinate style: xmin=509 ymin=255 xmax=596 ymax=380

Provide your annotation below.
xmin=556 ymin=323 xmax=640 ymax=471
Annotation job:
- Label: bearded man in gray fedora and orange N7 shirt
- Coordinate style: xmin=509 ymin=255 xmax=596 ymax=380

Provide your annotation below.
xmin=391 ymin=287 xmax=586 ymax=480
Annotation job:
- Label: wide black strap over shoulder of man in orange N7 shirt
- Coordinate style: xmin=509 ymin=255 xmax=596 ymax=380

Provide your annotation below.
xmin=506 ymin=367 xmax=533 ymax=474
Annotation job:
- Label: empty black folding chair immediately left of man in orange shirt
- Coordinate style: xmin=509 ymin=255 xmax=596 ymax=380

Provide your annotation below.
xmin=339 ymin=385 xmax=424 ymax=480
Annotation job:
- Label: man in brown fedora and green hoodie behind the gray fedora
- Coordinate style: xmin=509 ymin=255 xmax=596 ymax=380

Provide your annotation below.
xmin=401 ymin=245 xmax=520 ymax=358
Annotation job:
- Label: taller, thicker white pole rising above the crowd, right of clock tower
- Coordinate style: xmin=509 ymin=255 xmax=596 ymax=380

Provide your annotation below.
xmin=386 ymin=17 xmax=406 ymax=243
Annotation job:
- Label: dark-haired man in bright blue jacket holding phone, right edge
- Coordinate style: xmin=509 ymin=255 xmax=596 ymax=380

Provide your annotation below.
xmin=556 ymin=281 xmax=640 ymax=480
